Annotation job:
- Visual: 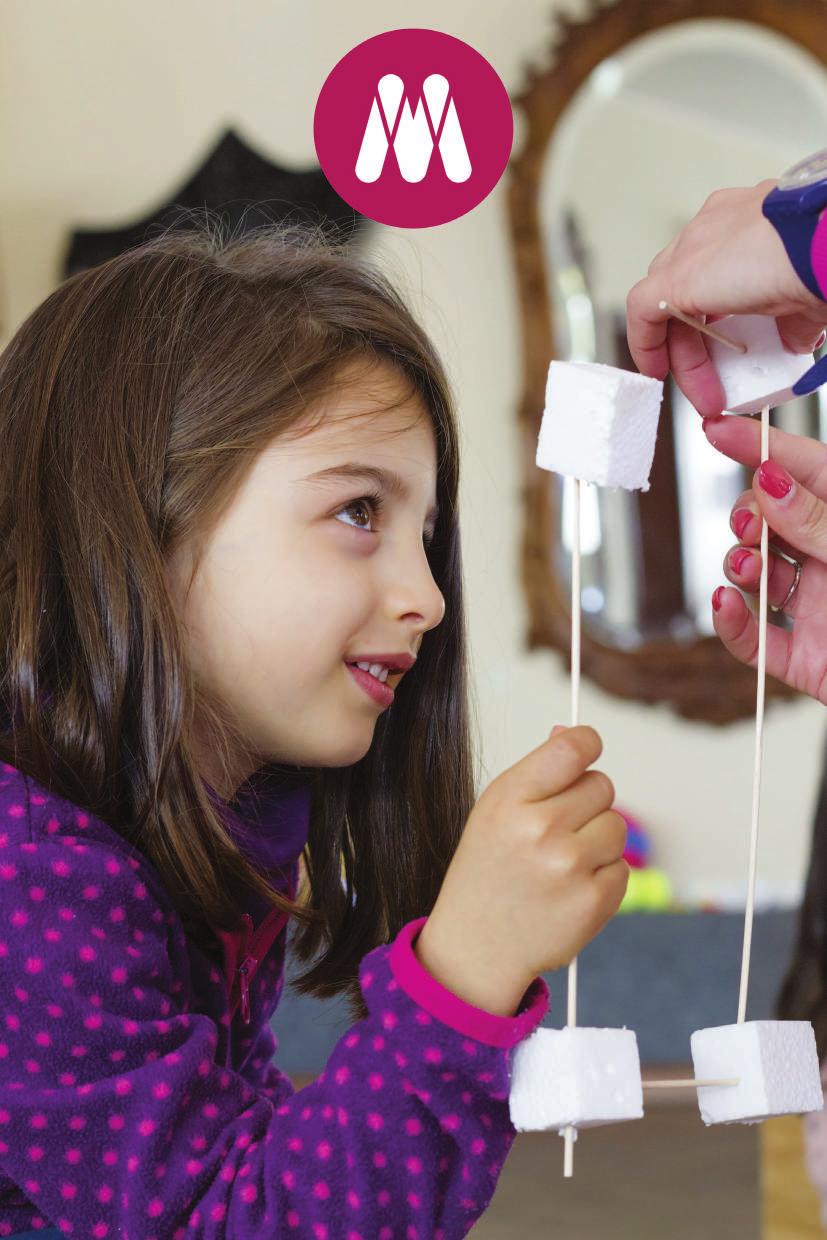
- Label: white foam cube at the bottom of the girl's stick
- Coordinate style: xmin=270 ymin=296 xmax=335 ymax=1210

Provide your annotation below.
xmin=508 ymin=1025 xmax=643 ymax=1133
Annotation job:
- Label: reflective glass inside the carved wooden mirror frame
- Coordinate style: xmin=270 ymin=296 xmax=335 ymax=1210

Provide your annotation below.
xmin=539 ymin=19 xmax=827 ymax=649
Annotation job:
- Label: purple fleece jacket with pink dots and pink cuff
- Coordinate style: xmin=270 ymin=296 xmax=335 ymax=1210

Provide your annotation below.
xmin=0 ymin=764 xmax=548 ymax=1240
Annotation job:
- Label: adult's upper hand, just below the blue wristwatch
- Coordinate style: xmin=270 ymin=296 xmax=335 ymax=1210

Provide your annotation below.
xmin=626 ymin=180 xmax=827 ymax=417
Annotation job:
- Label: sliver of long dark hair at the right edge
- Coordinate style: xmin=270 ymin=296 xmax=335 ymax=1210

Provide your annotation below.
xmin=776 ymin=734 xmax=827 ymax=1060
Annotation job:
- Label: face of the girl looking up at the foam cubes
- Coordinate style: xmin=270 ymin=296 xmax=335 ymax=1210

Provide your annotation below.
xmin=163 ymin=362 xmax=445 ymax=796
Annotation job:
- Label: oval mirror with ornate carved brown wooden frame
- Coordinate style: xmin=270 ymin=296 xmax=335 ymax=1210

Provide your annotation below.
xmin=508 ymin=0 xmax=827 ymax=723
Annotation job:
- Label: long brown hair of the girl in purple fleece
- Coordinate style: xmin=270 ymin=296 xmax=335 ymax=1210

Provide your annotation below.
xmin=0 ymin=213 xmax=476 ymax=1019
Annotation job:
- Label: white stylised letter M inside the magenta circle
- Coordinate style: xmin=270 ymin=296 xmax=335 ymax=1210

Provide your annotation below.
xmin=356 ymin=73 xmax=471 ymax=182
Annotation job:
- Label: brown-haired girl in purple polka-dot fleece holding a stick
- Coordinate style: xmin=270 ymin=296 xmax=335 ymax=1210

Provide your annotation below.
xmin=0 ymin=221 xmax=627 ymax=1240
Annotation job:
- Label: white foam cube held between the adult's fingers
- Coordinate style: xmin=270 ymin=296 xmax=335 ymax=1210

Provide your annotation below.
xmin=705 ymin=314 xmax=816 ymax=413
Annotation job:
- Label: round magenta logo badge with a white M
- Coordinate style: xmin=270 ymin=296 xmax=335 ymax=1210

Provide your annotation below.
xmin=312 ymin=29 xmax=515 ymax=228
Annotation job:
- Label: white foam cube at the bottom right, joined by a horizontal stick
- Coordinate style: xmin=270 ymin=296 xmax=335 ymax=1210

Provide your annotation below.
xmin=689 ymin=1021 xmax=825 ymax=1123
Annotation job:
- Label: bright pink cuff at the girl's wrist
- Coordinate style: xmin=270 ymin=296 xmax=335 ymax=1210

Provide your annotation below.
xmin=388 ymin=916 xmax=549 ymax=1047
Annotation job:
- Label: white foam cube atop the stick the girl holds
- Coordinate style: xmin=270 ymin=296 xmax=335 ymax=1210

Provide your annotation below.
xmin=536 ymin=361 xmax=663 ymax=491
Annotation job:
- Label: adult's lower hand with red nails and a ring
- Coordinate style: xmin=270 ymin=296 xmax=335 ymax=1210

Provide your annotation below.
xmin=703 ymin=406 xmax=827 ymax=704
